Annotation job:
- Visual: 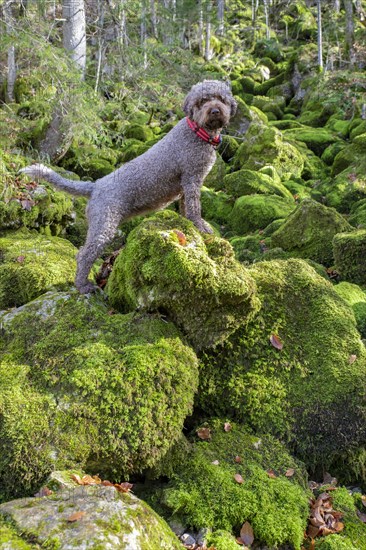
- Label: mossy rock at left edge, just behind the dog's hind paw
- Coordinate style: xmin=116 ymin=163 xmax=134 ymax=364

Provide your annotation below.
xmin=0 ymin=229 xmax=77 ymax=309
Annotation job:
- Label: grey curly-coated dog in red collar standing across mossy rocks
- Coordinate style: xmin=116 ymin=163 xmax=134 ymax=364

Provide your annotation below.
xmin=22 ymin=80 xmax=236 ymax=293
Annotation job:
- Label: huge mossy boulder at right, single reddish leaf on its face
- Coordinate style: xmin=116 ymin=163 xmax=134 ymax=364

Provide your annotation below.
xmin=199 ymin=259 xmax=366 ymax=476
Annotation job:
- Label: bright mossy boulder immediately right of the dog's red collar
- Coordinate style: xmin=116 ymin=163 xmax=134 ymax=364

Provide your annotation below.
xmin=233 ymin=123 xmax=304 ymax=179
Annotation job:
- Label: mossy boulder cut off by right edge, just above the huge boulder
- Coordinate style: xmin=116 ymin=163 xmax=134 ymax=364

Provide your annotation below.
xmin=333 ymin=229 xmax=366 ymax=285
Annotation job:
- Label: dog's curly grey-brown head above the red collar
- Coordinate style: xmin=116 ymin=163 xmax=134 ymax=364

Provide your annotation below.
xmin=183 ymin=80 xmax=237 ymax=131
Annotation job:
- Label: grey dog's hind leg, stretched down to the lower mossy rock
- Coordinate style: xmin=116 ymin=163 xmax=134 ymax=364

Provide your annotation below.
xmin=75 ymin=203 xmax=122 ymax=294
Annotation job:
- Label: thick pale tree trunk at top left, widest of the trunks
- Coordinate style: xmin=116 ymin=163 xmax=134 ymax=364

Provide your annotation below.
xmin=62 ymin=0 xmax=86 ymax=79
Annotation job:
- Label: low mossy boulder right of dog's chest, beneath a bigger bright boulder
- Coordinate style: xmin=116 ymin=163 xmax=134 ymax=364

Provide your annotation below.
xmin=224 ymin=170 xmax=292 ymax=200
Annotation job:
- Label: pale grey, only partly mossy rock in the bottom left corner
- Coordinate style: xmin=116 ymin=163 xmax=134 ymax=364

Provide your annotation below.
xmin=0 ymin=485 xmax=182 ymax=550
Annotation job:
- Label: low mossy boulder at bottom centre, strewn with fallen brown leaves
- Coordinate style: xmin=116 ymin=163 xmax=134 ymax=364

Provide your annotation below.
xmin=157 ymin=420 xmax=309 ymax=550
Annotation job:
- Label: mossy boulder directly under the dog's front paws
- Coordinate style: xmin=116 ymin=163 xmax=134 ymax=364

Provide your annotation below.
xmin=107 ymin=211 xmax=258 ymax=349
